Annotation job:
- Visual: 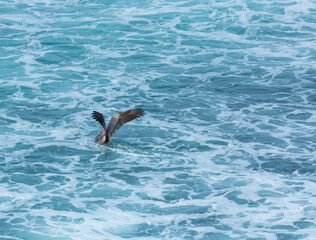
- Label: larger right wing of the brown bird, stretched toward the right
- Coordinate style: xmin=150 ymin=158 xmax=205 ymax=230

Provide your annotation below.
xmin=106 ymin=108 xmax=145 ymax=142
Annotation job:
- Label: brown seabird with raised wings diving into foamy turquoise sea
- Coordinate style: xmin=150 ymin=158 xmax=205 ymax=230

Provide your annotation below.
xmin=92 ymin=108 xmax=145 ymax=144
